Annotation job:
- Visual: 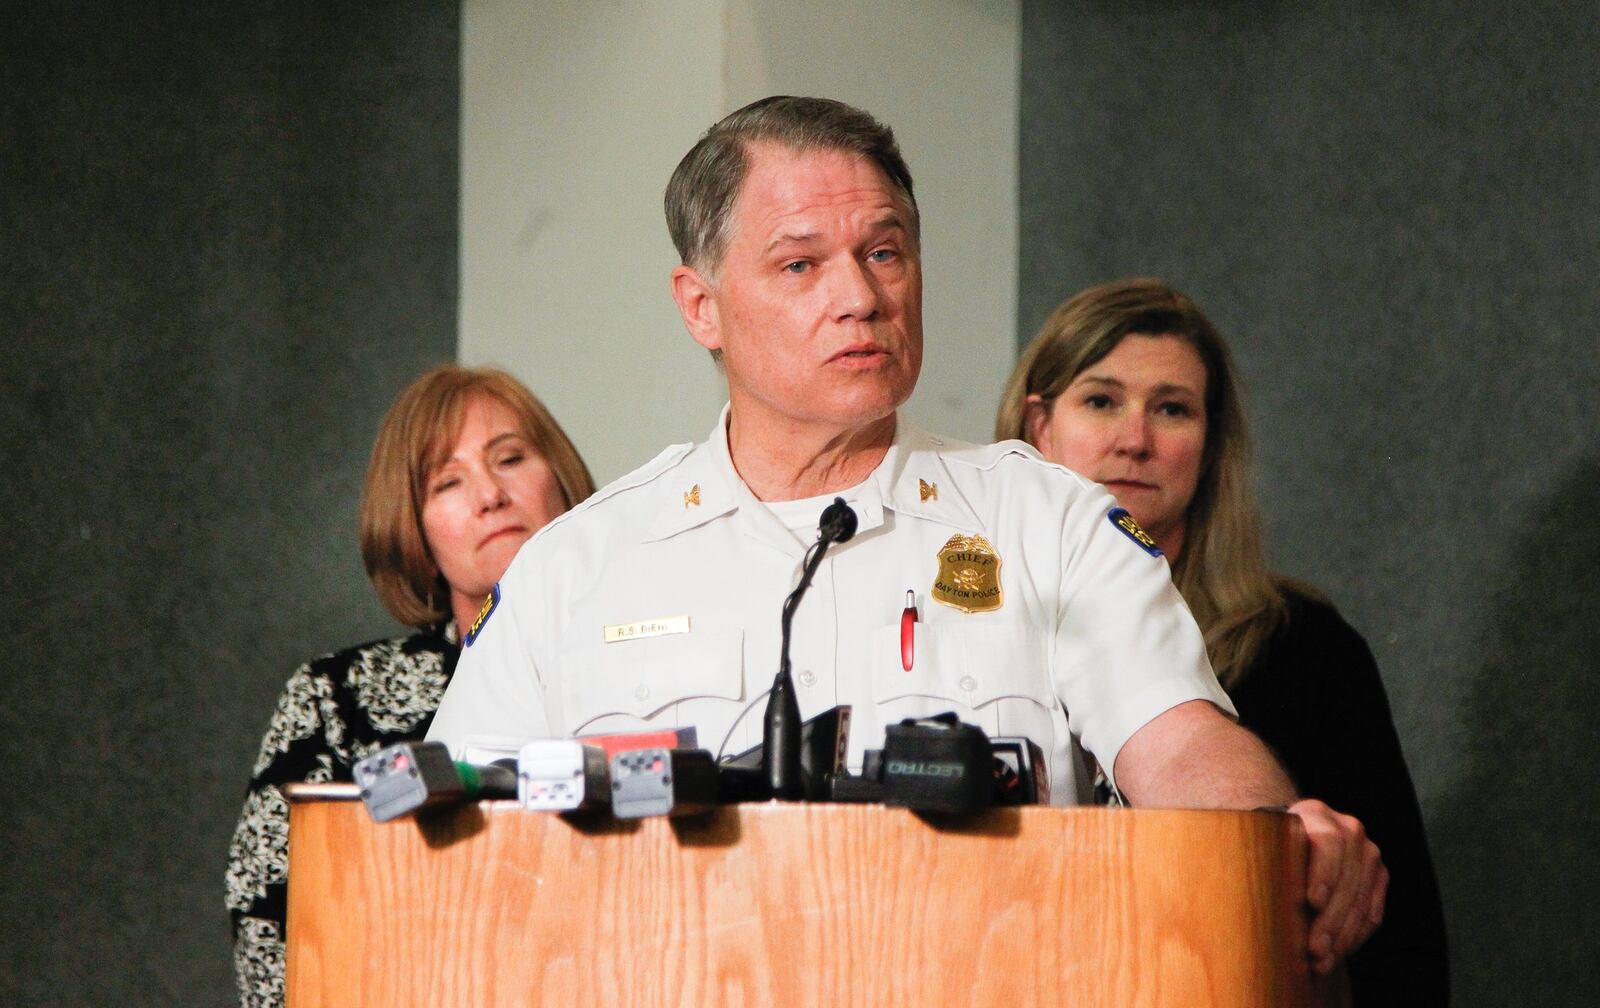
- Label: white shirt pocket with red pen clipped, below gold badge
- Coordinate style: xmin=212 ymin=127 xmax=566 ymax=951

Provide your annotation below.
xmin=872 ymin=621 xmax=1066 ymax=752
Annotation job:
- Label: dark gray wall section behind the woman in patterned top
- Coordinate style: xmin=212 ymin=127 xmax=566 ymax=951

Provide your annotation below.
xmin=0 ymin=0 xmax=459 ymax=1005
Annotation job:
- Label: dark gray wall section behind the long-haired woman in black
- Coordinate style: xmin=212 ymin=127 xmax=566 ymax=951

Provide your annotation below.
xmin=1019 ymin=0 xmax=1600 ymax=1005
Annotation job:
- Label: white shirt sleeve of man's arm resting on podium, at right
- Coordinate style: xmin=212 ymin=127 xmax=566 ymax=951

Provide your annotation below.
xmin=1054 ymin=486 xmax=1235 ymax=784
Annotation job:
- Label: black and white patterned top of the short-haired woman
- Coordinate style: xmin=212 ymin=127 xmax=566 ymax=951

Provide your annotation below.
xmin=226 ymin=626 xmax=461 ymax=1008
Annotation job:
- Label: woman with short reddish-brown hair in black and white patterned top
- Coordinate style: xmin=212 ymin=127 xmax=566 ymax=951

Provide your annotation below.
xmin=226 ymin=365 xmax=594 ymax=1006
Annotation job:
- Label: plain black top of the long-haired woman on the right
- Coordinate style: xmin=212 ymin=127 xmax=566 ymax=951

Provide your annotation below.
xmin=1229 ymin=592 xmax=1450 ymax=1008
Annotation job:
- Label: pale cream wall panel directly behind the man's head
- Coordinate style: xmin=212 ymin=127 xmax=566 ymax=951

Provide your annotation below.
xmin=461 ymin=0 xmax=1019 ymax=483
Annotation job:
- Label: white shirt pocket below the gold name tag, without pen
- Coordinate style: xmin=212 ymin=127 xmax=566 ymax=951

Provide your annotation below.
xmin=558 ymin=632 xmax=744 ymax=734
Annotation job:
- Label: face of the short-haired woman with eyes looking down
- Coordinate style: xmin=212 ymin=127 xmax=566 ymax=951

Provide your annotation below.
xmin=422 ymin=395 xmax=566 ymax=619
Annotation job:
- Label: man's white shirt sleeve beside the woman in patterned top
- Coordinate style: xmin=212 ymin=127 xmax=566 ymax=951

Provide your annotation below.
xmin=427 ymin=579 xmax=552 ymax=752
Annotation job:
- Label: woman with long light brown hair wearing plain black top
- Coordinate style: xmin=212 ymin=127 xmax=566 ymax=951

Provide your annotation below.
xmin=995 ymin=278 xmax=1450 ymax=1005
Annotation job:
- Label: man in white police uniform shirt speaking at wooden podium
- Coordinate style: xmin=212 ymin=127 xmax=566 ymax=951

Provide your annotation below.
xmin=429 ymin=98 xmax=1387 ymax=970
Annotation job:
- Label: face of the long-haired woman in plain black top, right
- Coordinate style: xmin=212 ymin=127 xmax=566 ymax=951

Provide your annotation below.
xmin=1027 ymin=336 xmax=1206 ymax=560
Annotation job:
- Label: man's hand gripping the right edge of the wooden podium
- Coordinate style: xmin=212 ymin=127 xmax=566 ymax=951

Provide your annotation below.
xmin=1290 ymin=798 xmax=1389 ymax=973
